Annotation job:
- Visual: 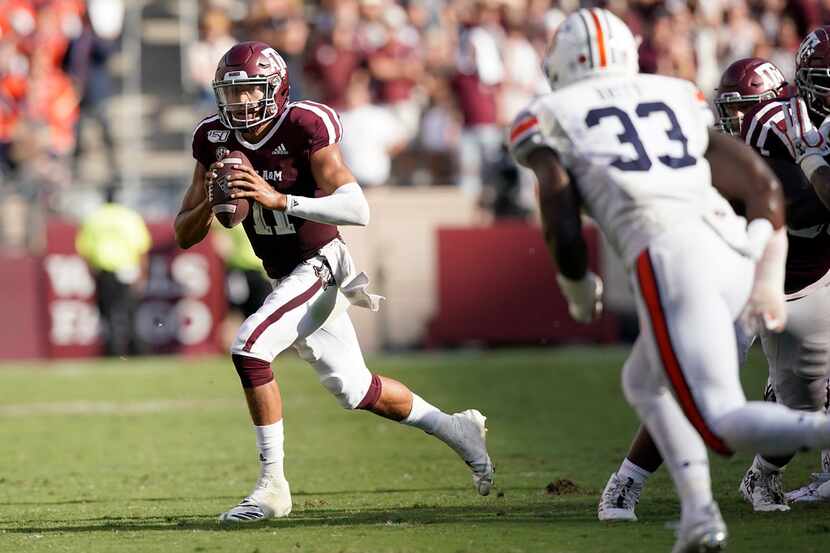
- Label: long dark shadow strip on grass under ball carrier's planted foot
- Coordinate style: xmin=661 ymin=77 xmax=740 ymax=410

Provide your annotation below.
xmin=4 ymin=500 xmax=608 ymax=534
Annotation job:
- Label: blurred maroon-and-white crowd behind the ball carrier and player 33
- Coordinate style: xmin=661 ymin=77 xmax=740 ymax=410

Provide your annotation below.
xmin=189 ymin=0 xmax=830 ymax=217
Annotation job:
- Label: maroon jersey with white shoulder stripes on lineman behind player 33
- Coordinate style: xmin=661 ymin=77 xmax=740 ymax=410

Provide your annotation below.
xmin=741 ymin=98 xmax=830 ymax=294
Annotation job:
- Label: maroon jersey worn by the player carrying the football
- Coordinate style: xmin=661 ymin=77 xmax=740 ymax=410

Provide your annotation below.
xmin=193 ymin=101 xmax=343 ymax=278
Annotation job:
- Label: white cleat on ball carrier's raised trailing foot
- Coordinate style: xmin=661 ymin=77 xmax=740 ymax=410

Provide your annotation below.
xmin=447 ymin=409 xmax=496 ymax=495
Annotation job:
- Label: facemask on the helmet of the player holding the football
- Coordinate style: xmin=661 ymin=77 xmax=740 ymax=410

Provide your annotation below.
xmin=213 ymin=72 xmax=282 ymax=130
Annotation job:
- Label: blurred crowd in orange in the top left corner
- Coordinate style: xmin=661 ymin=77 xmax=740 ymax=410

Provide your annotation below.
xmin=0 ymin=0 xmax=124 ymax=248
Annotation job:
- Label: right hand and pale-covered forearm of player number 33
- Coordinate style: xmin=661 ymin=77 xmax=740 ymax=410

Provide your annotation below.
xmin=741 ymin=227 xmax=787 ymax=334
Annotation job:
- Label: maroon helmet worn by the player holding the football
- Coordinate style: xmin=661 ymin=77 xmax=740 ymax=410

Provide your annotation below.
xmin=213 ymin=42 xmax=288 ymax=129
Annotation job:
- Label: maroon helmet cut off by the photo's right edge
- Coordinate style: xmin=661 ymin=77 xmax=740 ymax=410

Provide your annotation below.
xmin=795 ymin=25 xmax=830 ymax=118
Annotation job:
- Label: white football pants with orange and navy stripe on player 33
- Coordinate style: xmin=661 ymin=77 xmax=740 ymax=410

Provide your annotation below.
xmin=623 ymin=221 xmax=830 ymax=515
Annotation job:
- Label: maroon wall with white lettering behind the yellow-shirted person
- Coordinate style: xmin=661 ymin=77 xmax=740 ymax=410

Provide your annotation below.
xmin=0 ymin=221 xmax=226 ymax=358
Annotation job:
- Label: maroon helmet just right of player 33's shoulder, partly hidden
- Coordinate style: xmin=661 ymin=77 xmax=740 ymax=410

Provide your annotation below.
xmin=715 ymin=58 xmax=787 ymax=135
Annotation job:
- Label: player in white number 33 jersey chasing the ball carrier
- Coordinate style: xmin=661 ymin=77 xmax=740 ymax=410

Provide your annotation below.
xmin=511 ymin=9 xmax=830 ymax=553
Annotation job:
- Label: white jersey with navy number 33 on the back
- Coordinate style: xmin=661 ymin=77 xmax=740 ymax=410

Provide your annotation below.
xmin=510 ymin=75 xmax=746 ymax=266
